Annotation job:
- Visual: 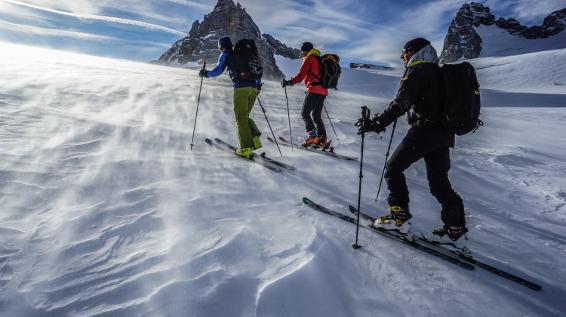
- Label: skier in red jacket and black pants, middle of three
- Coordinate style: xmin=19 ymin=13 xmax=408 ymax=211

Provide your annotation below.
xmin=281 ymin=42 xmax=330 ymax=149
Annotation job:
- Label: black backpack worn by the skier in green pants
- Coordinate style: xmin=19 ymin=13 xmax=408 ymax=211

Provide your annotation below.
xmin=234 ymin=39 xmax=263 ymax=82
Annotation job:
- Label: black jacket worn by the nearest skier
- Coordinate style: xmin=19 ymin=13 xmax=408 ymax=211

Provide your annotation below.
xmin=379 ymin=62 xmax=454 ymax=147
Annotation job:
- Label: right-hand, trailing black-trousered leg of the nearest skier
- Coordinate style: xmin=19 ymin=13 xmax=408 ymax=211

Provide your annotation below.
xmin=424 ymin=147 xmax=466 ymax=226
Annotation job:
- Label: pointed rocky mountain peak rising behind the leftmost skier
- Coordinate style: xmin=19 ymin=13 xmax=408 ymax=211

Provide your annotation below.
xmin=158 ymin=0 xmax=284 ymax=79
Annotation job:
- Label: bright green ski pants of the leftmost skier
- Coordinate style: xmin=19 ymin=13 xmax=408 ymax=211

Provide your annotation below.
xmin=234 ymin=87 xmax=260 ymax=149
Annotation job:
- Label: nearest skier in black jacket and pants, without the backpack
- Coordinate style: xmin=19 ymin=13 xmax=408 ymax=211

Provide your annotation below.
xmin=358 ymin=38 xmax=468 ymax=248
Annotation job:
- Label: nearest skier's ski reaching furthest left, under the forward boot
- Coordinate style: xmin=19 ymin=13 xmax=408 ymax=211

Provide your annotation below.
xmin=303 ymin=197 xmax=475 ymax=271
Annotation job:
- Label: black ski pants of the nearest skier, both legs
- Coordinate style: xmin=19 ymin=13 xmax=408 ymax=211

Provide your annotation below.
xmin=385 ymin=132 xmax=466 ymax=226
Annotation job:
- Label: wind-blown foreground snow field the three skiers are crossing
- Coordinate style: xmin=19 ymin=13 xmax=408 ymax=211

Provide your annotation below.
xmin=0 ymin=43 xmax=566 ymax=316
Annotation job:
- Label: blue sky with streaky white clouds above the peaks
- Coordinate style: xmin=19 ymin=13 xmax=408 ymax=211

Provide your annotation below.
xmin=0 ymin=0 xmax=566 ymax=65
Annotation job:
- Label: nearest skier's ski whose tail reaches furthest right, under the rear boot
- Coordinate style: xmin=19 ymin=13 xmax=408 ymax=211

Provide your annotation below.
xmin=349 ymin=206 xmax=542 ymax=291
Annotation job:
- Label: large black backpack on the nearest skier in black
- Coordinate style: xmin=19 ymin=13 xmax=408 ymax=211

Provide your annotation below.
xmin=440 ymin=62 xmax=483 ymax=135
